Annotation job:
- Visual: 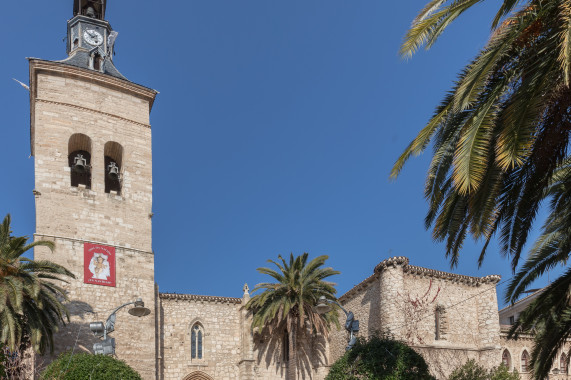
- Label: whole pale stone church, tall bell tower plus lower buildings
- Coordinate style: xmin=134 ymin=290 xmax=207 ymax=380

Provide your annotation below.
xmin=25 ymin=0 xmax=567 ymax=380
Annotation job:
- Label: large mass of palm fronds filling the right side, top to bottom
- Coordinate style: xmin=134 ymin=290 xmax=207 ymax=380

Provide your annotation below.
xmin=391 ymin=0 xmax=571 ymax=378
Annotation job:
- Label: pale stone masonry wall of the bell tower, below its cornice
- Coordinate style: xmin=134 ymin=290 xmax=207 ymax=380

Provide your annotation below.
xmin=30 ymin=60 xmax=156 ymax=380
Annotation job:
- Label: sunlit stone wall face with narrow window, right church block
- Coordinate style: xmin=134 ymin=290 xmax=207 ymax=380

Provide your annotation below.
xmin=400 ymin=273 xmax=500 ymax=379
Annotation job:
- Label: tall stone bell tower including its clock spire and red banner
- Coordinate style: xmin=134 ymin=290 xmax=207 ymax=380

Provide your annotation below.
xmin=29 ymin=0 xmax=157 ymax=379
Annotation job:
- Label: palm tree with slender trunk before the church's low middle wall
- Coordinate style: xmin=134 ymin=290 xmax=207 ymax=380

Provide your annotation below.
xmin=245 ymin=253 xmax=340 ymax=380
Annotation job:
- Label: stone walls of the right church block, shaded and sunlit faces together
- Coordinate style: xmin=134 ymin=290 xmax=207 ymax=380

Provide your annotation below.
xmin=330 ymin=257 xmax=501 ymax=379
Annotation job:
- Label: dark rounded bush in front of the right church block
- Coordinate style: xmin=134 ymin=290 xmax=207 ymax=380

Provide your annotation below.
xmin=325 ymin=336 xmax=434 ymax=380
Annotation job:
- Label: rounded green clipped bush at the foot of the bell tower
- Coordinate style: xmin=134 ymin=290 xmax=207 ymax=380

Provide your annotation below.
xmin=41 ymin=352 xmax=142 ymax=380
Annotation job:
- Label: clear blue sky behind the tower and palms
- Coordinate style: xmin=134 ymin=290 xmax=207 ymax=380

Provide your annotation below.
xmin=0 ymin=0 xmax=556 ymax=303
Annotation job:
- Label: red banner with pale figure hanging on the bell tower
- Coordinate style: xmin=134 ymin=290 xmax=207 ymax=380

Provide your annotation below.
xmin=83 ymin=243 xmax=115 ymax=286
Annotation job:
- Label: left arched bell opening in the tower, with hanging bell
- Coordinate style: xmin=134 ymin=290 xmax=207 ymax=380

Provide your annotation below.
xmin=67 ymin=133 xmax=91 ymax=189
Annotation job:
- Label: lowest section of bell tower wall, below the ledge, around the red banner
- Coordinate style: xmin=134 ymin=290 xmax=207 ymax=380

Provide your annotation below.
xmin=35 ymin=238 xmax=155 ymax=379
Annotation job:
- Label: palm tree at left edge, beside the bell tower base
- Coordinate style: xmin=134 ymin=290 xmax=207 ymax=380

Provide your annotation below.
xmin=0 ymin=214 xmax=75 ymax=353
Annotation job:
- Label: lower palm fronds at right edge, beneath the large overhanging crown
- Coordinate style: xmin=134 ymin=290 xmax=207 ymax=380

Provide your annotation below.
xmin=506 ymin=158 xmax=571 ymax=379
